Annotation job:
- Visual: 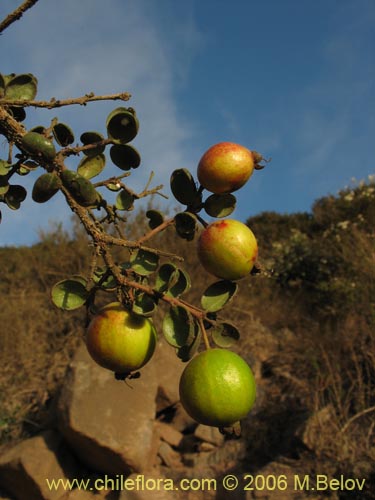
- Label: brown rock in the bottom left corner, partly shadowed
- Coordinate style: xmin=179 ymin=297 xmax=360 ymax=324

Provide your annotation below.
xmin=0 ymin=431 xmax=77 ymax=500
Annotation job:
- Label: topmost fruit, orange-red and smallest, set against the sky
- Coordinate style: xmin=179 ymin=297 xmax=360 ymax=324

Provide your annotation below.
xmin=197 ymin=142 xmax=254 ymax=194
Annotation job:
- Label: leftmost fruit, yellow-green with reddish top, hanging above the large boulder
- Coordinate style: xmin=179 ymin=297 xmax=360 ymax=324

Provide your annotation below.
xmin=86 ymin=302 xmax=156 ymax=373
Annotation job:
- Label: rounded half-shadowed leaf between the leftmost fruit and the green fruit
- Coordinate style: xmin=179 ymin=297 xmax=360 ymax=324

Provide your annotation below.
xmin=162 ymin=306 xmax=195 ymax=347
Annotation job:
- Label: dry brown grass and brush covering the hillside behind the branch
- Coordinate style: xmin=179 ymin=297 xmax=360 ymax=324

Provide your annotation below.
xmin=0 ymin=179 xmax=375 ymax=498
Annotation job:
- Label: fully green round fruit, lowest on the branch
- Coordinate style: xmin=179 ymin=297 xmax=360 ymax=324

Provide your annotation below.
xmin=179 ymin=348 xmax=256 ymax=427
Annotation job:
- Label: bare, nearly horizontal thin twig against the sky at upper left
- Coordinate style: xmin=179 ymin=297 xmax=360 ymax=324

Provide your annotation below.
xmin=0 ymin=92 xmax=131 ymax=109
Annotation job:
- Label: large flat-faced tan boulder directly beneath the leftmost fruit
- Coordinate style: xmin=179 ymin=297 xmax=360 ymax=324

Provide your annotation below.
xmin=57 ymin=344 xmax=157 ymax=474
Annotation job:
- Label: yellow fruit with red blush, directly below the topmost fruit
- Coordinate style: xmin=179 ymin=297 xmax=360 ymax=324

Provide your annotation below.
xmin=198 ymin=219 xmax=258 ymax=280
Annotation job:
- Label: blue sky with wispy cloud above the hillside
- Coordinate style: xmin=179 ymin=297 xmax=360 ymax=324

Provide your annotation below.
xmin=0 ymin=0 xmax=375 ymax=245
